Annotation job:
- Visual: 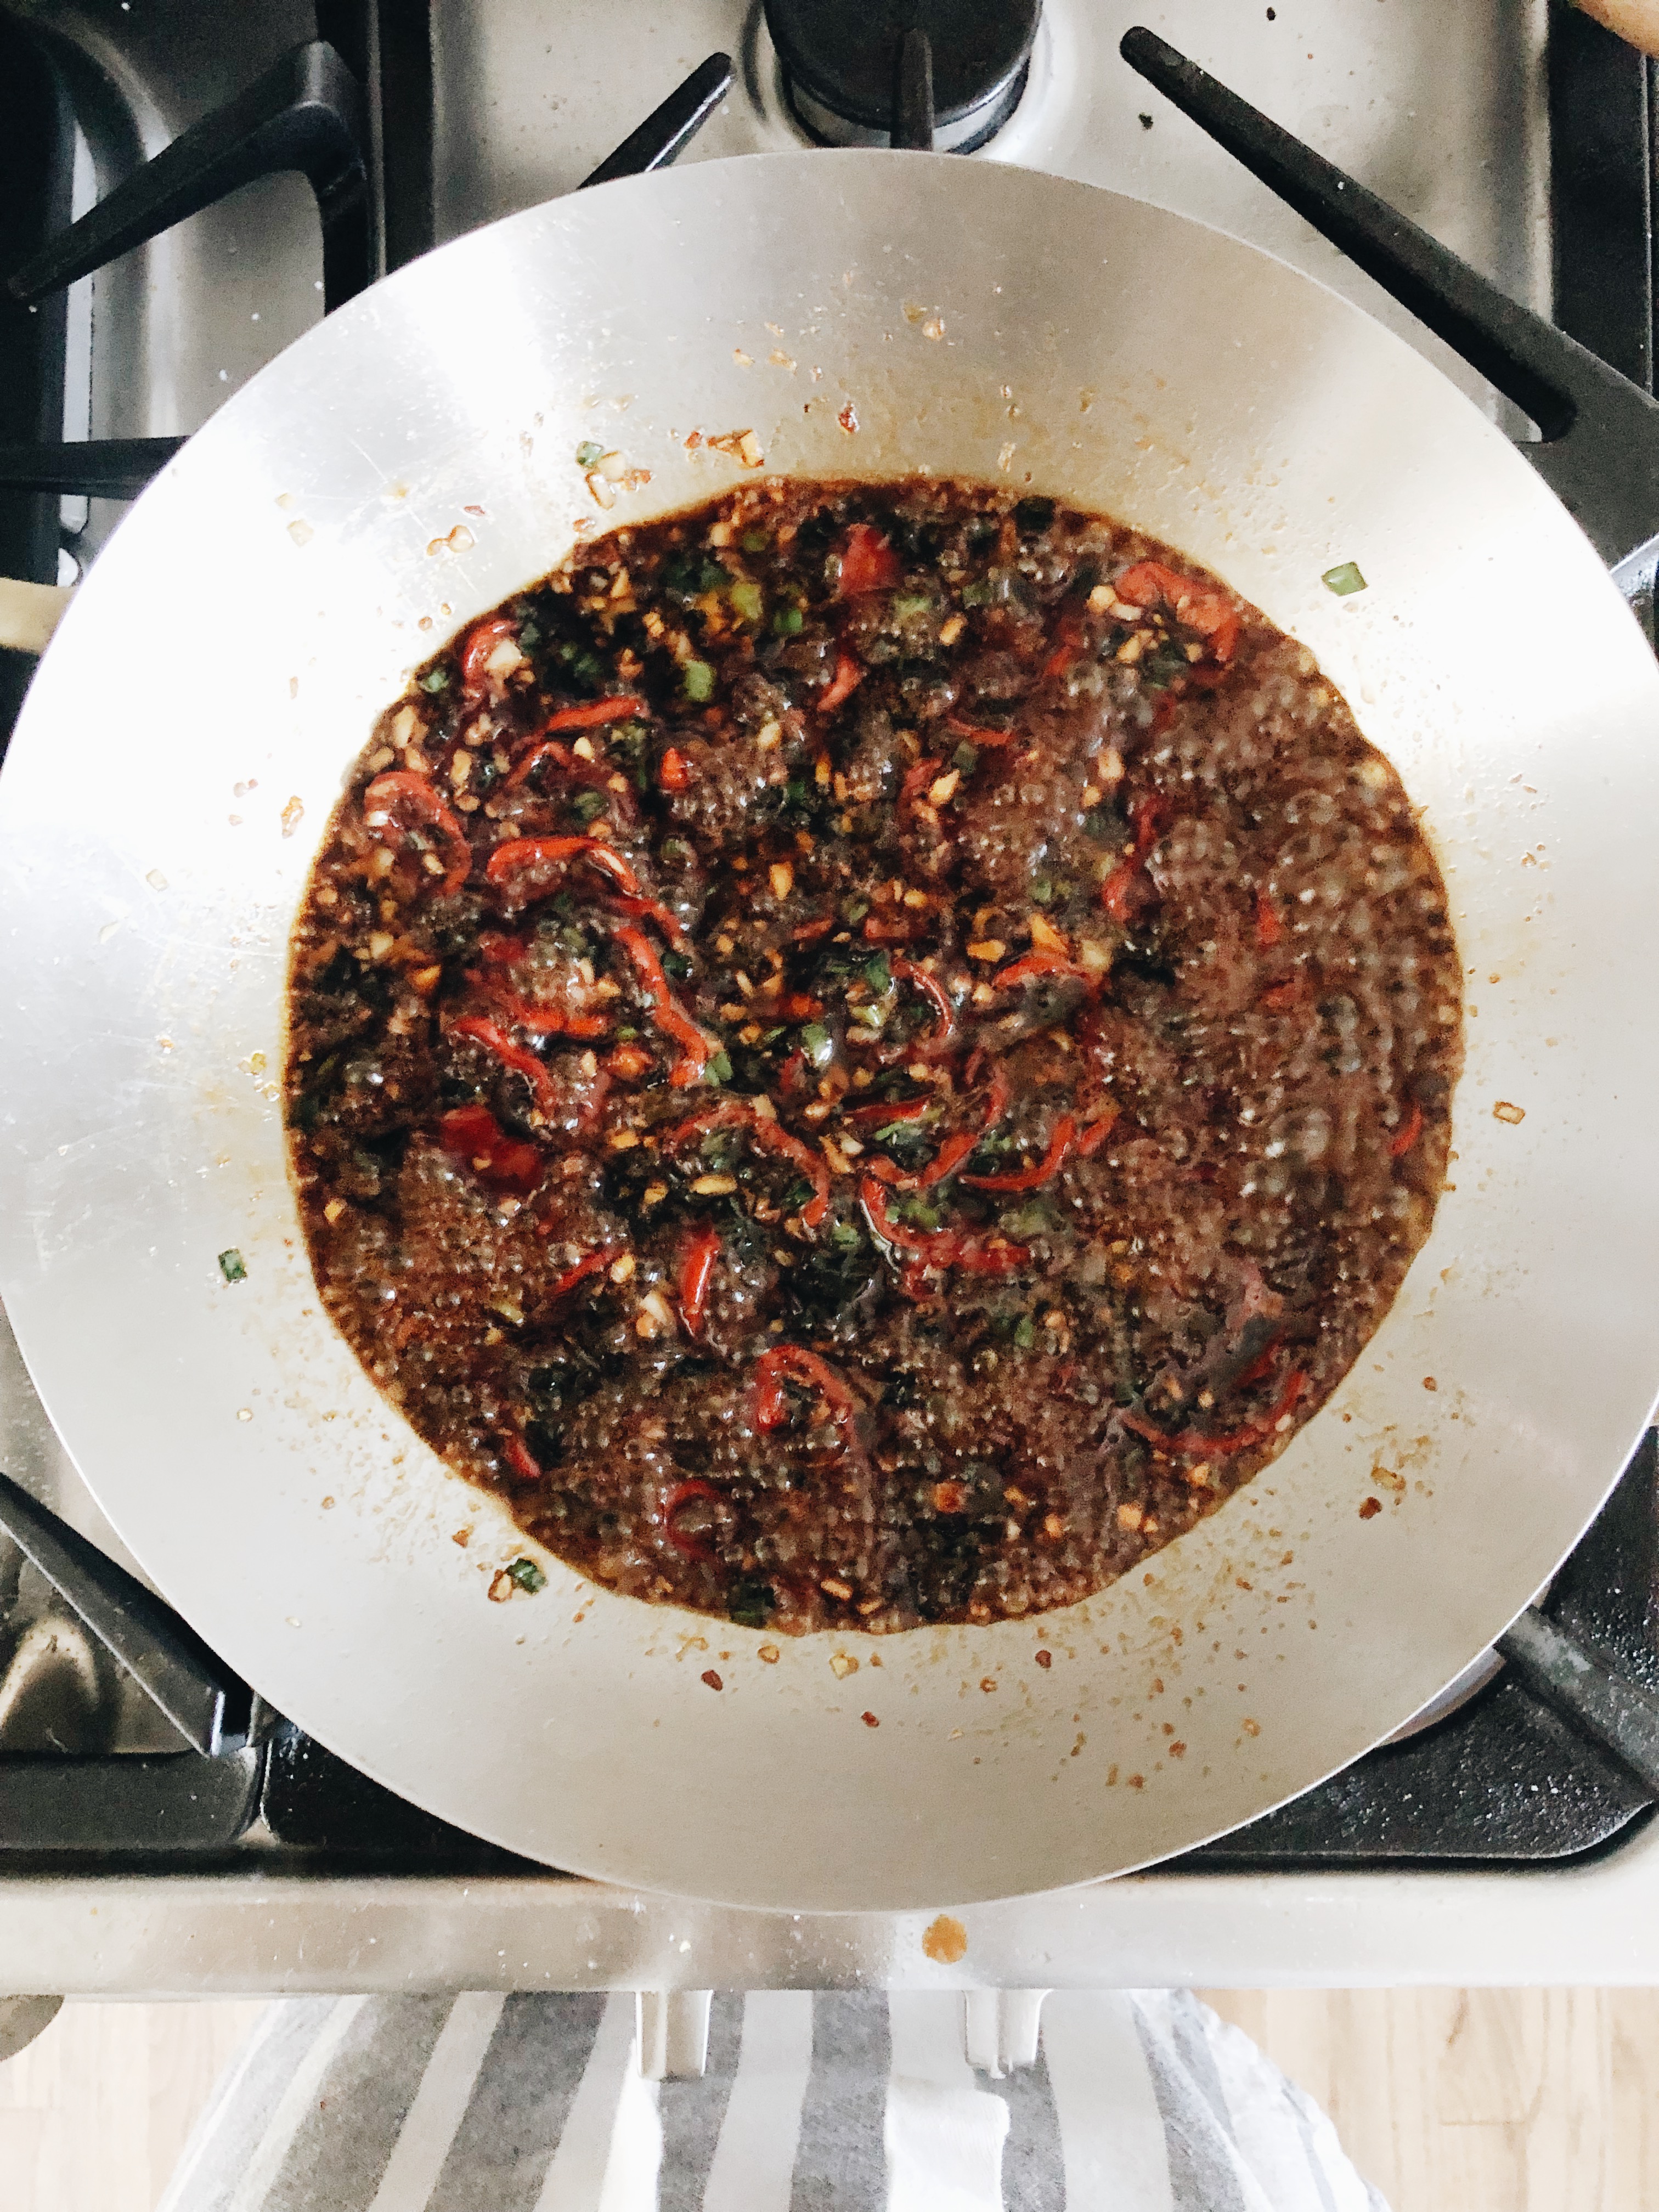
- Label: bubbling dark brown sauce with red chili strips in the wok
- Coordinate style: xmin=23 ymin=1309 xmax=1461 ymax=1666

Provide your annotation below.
xmin=285 ymin=480 xmax=1462 ymax=1633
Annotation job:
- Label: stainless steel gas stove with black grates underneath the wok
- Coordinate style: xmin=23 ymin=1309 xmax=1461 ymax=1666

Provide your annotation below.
xmin=0 ymin=0 xmax=1659 ymax=1993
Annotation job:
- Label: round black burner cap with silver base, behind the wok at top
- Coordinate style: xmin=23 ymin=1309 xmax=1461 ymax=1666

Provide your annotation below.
xmin=765 ymin=0 xmax=1042 ymax=153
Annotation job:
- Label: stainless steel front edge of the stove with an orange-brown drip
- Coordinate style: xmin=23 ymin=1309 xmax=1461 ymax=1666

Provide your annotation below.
xmin=0 ymin=1825 xmax=1659 ymax=1997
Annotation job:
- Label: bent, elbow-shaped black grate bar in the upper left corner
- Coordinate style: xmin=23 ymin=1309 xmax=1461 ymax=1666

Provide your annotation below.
xmin=9 ymin=38 xmax=374 ymax=318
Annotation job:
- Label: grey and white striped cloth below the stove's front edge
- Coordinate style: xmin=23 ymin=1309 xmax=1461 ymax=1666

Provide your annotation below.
xmin=157 ymin=1989 xmax=1387 ymax=2212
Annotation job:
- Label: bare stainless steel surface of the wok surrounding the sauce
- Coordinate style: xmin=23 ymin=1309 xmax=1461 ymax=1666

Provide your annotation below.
xmin=0 ymin=153 xmax=1659 ymax=1909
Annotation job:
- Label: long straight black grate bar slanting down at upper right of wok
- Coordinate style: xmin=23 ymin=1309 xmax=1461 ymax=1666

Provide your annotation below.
xmin=1119 ymin=29 xmax=1659 ymax=566
